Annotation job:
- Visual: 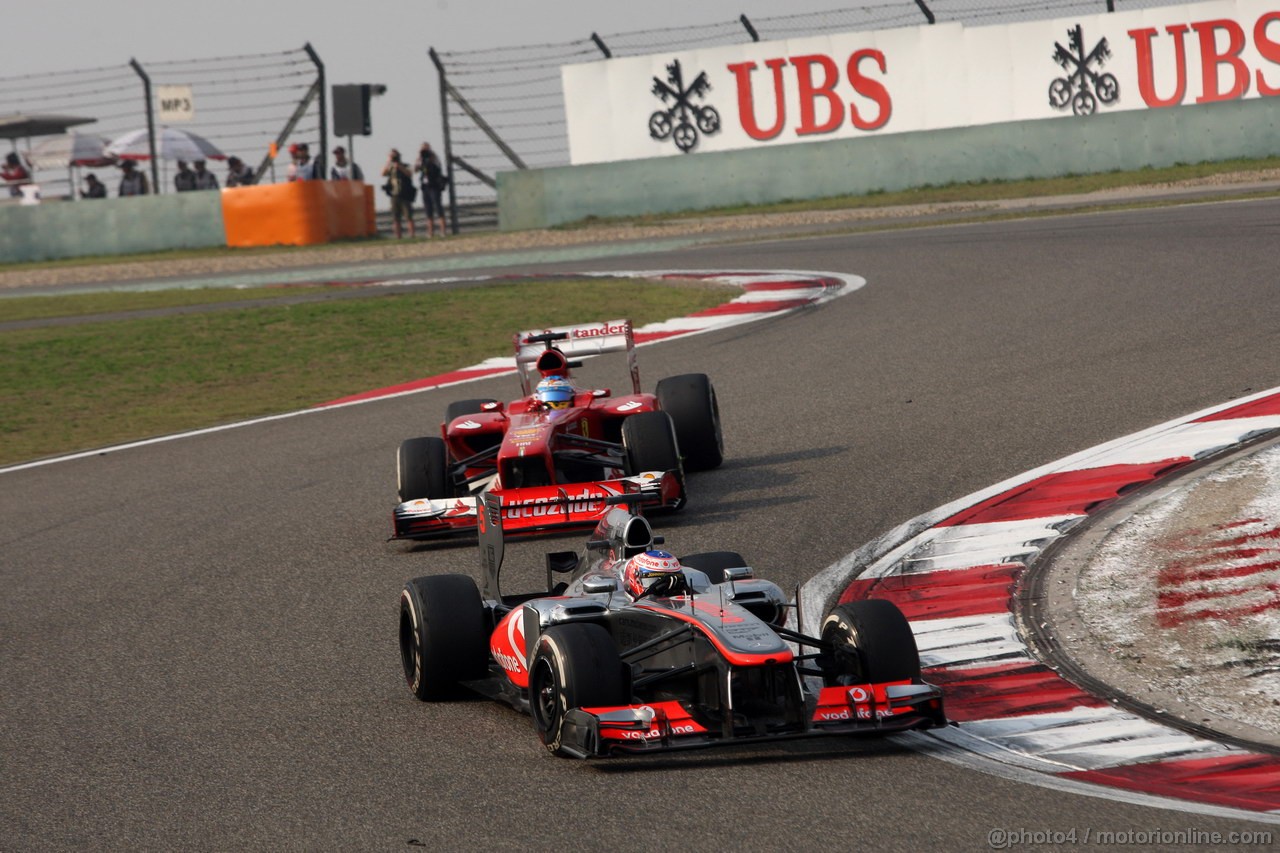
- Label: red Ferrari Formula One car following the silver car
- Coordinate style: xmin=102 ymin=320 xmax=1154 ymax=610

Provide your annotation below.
xmin=392 ymin=320 xmax=724 ymax=539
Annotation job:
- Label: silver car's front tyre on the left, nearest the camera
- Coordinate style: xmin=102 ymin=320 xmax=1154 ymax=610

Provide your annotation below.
xmin=529 ymin=624 xmax=630 ymax=757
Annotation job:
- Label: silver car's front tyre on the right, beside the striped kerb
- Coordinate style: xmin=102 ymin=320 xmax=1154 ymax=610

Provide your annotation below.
xmin=819 ymin=598 xmax=920 ymax=686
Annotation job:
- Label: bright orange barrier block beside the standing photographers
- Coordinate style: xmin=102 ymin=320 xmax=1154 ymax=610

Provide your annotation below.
xmin=223 ymin=181 xmax=376 ymax=246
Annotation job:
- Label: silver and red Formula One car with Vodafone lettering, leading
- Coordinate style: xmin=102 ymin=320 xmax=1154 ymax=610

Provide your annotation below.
xmin=399 ymin=493 xmax=947 ymax=758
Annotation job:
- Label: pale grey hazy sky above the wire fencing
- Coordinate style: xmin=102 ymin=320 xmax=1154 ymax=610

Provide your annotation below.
xmin=10 ymin=0 xmax=855 ymax=179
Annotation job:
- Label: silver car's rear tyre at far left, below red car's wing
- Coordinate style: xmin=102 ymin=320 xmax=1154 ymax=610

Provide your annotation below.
xmin=399 ymin=575 xmax=489 ymax=702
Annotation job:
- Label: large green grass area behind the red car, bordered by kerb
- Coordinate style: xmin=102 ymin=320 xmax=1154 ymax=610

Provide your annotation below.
xmin=0 ymin=279 xmax=732 ymax=464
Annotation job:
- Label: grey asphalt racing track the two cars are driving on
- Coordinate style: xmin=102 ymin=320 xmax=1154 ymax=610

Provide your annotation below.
xmin=0 ymin=200 xmax=1280 ymax=850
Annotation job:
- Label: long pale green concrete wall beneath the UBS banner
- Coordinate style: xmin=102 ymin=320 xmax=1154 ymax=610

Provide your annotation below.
xmin=498 ymin=97 xmax=1280 ymax=231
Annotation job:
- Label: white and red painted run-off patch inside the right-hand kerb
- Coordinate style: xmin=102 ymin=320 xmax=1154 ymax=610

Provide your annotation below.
xmin=1073 ymin=443 xmax=1280 ymax=744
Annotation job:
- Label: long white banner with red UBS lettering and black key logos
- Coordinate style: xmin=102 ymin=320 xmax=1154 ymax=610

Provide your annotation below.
xmin=561 ymin=0 xmax=1280 ymax=165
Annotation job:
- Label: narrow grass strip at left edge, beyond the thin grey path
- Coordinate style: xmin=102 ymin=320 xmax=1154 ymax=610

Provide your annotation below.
xmin=0 ymin=284 xmax=332 ymax=323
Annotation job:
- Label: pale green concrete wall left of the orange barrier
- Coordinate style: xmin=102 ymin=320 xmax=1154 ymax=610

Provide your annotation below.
xmin=0 ymin=192 xmax=227 ymax=264
